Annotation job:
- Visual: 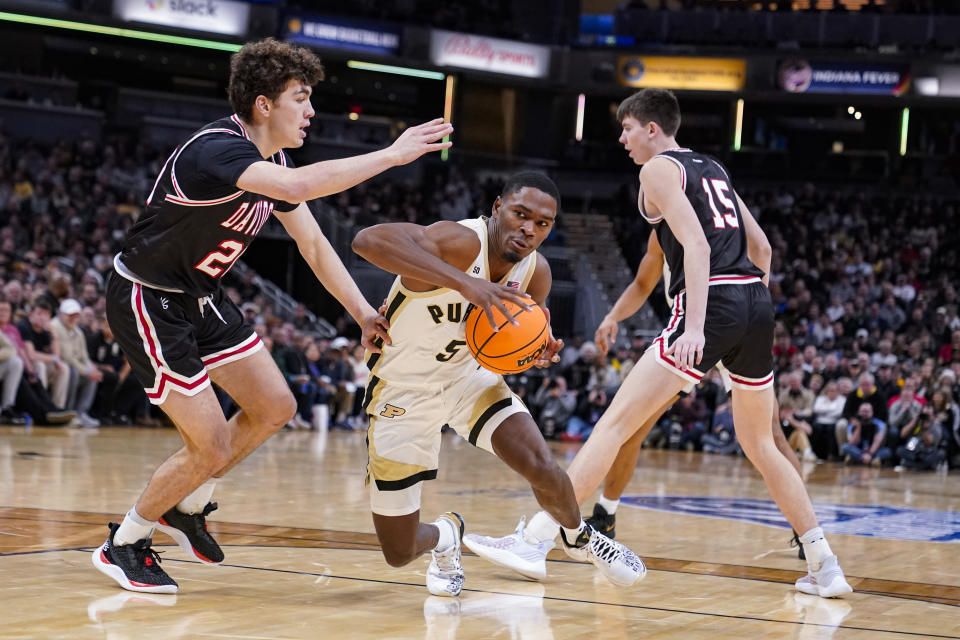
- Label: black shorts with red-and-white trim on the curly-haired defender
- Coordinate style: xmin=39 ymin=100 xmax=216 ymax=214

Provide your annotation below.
xmin=106 ymin=272 xmax=263 ymax=404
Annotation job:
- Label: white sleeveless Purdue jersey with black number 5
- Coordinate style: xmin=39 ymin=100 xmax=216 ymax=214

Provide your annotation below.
xmin=367 ymin=217 xmax=537 ymax=387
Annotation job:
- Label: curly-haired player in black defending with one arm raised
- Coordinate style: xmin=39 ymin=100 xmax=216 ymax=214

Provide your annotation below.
xmin=93 ymin=39 xmax=453 ymax=593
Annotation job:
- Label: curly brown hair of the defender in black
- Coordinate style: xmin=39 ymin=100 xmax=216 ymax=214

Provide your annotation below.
xmin=227 ymin=38 xmax=323 ymax=120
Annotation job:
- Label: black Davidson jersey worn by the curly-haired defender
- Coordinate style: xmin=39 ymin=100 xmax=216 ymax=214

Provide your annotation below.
xmin=114 ymin=115 xmax=297 ymax=298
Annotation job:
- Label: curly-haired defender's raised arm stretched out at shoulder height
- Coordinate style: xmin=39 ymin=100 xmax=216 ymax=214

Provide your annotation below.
xmin=237 ymin=118 xmax=453 ymax=203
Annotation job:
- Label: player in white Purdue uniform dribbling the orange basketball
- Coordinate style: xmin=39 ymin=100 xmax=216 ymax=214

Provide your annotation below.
xmin=353 ymin=172 xmax=646 ymax=596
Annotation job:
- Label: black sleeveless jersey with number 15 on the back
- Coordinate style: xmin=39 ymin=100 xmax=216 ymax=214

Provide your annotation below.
xmin=639 ymin=149 xmax=763 ymax=298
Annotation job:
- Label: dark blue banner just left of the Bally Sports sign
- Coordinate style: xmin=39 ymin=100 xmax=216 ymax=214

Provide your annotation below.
xmin=283 ymin=12 xmax=400 ymax=55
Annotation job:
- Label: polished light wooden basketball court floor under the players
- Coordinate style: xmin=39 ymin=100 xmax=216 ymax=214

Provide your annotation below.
xmin=0 ymin=428 xmax=960 ymax=640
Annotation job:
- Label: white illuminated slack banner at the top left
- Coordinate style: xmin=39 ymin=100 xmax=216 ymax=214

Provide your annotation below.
xmin=113 ymin=0 xmax=250 ymax=36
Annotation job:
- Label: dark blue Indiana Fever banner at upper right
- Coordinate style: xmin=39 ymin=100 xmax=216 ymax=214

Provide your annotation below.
xmin=777 ymin=58 xmax=910 ymax=96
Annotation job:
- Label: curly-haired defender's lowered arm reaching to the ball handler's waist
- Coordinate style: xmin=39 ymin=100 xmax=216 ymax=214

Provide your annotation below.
xmin=282 ymin=204 xmax=390 ymax=353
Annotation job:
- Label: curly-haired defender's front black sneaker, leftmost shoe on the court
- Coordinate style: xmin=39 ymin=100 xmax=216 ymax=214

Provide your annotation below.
xmin=93 ymin=522 xmax=180 ymax=593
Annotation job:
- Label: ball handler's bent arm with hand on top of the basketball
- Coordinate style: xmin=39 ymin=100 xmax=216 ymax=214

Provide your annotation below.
xmin=353 ymin=221 xmax=530 ymax=327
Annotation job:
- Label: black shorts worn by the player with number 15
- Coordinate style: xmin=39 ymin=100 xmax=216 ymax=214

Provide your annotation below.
xmin=650 ymin=276 xmax=774 ymax=390
